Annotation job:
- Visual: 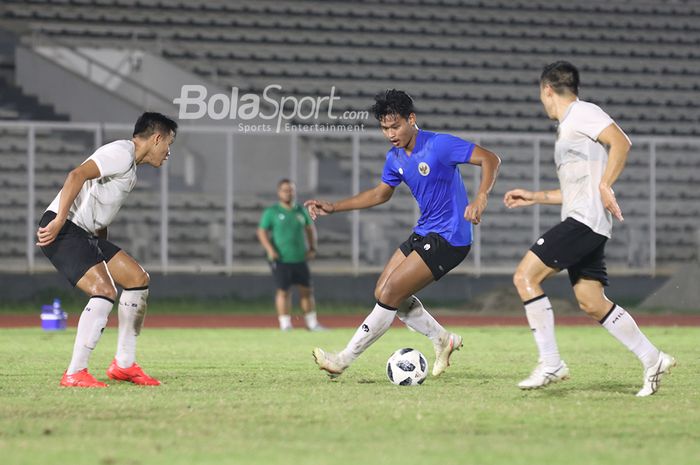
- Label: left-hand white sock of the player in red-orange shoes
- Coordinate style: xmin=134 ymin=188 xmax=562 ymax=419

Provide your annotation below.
xmin=66 ymin=296 xmax=114 ymax=375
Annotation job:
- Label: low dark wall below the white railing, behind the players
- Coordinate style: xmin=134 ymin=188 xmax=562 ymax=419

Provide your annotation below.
xmin=0 ymin=273 xmax=668 ymax=311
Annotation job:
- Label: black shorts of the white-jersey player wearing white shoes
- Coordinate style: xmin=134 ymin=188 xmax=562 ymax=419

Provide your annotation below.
xmin=530 ymin=218 xmax=608 ymax=286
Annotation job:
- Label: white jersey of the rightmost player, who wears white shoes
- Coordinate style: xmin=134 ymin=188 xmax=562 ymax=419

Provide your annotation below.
xmin=554 ymin=100 xmax=614 ymax=238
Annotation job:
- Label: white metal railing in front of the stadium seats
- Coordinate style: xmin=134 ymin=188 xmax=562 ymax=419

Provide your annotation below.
xmin=0 ymin=121 xmax=700 ymax=275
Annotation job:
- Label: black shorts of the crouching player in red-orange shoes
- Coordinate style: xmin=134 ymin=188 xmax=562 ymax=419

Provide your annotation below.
xmin=39 ymin=211 xmax=121 ymax=287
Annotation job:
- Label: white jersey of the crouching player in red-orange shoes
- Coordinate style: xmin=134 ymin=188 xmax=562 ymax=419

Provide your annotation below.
xmin=47 ymin=140 xmax=136 ymax=234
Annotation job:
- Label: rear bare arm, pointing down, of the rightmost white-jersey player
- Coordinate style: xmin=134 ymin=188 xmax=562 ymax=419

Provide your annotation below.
xmin=598 ymin=123 xmax=632 ymax=221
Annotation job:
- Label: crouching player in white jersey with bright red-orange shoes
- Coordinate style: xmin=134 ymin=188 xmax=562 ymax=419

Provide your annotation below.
xmin=37 ymin=113 xmax=177 ymax=387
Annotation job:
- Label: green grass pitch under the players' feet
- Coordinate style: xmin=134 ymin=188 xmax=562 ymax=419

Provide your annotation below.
xmin=0 ymin=327 xmax=700 ymax=465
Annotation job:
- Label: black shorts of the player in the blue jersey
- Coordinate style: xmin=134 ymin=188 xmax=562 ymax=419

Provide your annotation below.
xmin=399 ymin=233 xmax=471 ymax=281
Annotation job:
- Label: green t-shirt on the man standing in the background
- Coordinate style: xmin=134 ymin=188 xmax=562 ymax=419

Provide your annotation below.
xmin=259 ymin=203 xmax=311 ymax=263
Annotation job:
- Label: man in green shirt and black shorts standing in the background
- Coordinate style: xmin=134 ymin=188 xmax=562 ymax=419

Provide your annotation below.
xmin=258 ymin=179 xmax=324 ymax=331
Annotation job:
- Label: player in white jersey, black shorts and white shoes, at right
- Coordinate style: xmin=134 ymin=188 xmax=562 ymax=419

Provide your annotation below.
xmin=504 ymin=61 xmax=676 ymax=397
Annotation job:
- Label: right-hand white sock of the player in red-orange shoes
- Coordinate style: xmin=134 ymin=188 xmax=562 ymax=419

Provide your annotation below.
xmin=114 ymin=288 xmax=148 ymax=368
